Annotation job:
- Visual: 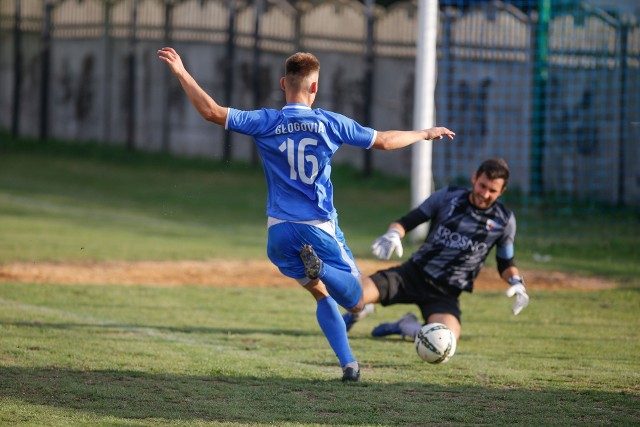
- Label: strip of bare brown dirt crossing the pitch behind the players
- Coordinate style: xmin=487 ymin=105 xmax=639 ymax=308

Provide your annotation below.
xmin=0 ymin=259 xmax=616 ymax=291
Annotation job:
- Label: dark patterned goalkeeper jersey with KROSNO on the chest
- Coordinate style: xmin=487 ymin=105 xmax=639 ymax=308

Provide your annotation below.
xmin=410 ymin=187 xmax=516 ymax=292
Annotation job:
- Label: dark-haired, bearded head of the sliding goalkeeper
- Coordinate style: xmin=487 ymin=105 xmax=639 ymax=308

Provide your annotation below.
xmin=469 ymin=158 xmax=509 ymax=209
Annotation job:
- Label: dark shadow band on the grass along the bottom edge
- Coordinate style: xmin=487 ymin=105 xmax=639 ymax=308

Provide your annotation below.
xmin=0 ymin=367 xmax=640 ymax=425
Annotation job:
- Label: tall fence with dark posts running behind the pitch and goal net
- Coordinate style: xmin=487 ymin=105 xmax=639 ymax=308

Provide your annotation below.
xmin=0 ymin=0 xmax=640 ymax=205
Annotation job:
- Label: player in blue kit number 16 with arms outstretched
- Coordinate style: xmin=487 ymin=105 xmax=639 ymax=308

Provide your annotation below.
xmin=158 ymin=47 xmax=455 ymax=381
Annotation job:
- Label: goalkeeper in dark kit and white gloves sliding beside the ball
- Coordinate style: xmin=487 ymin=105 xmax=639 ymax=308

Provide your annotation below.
xmin=343 ymin=159 xmax=529 ymax=339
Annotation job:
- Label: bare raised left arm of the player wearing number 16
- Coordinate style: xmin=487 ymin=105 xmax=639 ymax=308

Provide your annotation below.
xmin=158 ymin=47 xmax=228 ymax=126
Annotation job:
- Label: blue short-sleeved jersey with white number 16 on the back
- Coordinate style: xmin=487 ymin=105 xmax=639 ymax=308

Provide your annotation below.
xmin=225 ymin=104 xmax=376 ymax=221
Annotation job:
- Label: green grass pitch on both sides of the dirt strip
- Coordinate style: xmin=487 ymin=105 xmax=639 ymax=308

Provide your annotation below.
xmin=0 ymin=136 xmax=640 ymax=426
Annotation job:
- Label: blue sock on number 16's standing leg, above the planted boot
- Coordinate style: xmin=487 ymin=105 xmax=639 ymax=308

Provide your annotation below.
xmin=316 ymin=297 xmax=356 ymax=366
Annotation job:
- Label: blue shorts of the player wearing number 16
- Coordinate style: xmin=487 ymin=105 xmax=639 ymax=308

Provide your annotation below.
xmin=267 ymin=221 xmax=360 ymax=285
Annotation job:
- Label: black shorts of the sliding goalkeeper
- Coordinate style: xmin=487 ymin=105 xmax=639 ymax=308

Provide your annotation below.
xmin=371 ymin=261 xmax=462 ymax=322
